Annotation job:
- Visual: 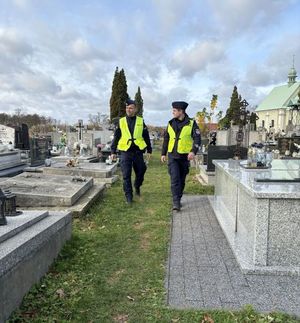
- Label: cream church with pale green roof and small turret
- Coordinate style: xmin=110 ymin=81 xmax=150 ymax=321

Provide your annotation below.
xmin=255 ymin=66 xmax=300 ymax=131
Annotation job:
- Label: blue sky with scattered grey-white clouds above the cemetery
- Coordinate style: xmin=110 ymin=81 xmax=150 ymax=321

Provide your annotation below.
xmin=0 ymin=0 xmax=300 ymax=125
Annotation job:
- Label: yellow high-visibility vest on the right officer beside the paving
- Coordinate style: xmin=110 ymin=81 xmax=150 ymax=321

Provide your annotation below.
xmin=167 ymin=120 xmax=194 ymax=154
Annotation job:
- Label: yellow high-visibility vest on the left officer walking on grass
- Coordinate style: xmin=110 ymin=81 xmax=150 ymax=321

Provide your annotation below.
xmin=118 ymin=116 xmax=147 ymax=151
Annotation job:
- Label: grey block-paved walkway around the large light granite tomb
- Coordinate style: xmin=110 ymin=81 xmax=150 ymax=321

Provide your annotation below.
xmin=167 ymin=195 xmax=300 ymax=316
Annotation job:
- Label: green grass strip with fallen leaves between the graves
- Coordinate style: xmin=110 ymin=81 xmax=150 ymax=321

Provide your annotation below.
xmin=9 ymin=152 xmax=299 ymax=323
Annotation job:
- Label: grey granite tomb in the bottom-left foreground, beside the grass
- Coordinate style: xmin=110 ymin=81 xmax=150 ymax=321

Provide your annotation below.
xmin=0 ymin=211 xmax=72 ymax=322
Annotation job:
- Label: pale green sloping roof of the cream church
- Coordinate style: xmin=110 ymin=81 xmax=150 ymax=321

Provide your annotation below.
xmin=255 ymin=82 xmax=300 ymax=112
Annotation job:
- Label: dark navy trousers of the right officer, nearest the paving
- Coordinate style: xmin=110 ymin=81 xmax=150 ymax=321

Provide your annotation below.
xmin=168 ymin=154 xmax=190 ymax=203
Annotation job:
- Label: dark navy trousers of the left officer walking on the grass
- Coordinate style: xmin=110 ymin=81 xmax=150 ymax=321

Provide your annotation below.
xmin=120 ymin=150 xmax=147 ymax=198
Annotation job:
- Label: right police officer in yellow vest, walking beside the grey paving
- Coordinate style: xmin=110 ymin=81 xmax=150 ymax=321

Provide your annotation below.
xmin=161 ymin=101 xmax=201 ymax=211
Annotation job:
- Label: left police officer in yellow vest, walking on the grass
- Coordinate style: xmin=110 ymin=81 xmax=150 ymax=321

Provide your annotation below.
xmin=111 ymin=99 xmax=152 ymax=204
